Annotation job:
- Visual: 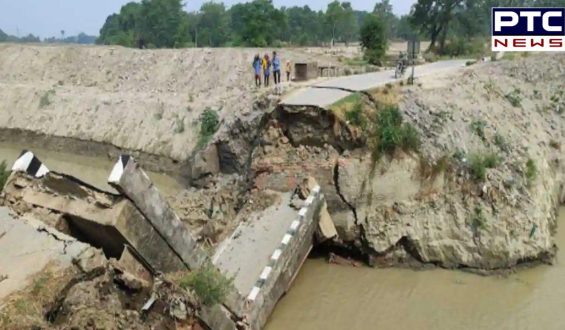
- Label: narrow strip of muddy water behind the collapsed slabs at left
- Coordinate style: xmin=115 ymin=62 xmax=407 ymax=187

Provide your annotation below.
xmin=0 ymin=142 xmax=182 ymax=195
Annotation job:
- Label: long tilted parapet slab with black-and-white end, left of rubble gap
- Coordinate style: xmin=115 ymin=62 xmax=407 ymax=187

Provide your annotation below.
xmin=108 ymin=155 xmax=209 ymax=270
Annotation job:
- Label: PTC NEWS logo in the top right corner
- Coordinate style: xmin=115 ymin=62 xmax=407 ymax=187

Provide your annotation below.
xmin=491 ymin=8 xmax=565 ymax=51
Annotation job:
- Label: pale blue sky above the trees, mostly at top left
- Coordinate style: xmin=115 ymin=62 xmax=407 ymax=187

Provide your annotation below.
xmin=0 ymin=0 xmax=416 ymax=38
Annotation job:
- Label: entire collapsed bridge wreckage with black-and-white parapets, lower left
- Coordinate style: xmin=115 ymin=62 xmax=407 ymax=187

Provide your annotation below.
xmin=0 ymin=151 xmax=335 ymax=329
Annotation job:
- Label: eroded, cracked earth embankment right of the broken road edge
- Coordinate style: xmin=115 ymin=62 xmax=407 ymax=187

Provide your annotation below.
xmin=253 ymin=55 xmax=565 ymax=270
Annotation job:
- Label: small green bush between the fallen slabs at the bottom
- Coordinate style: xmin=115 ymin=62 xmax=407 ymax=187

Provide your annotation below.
xmin=180 ymin=264 xmax=233 ymax=306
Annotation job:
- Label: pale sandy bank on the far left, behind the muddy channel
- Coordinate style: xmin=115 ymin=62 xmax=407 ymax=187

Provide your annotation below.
xmin=0 ymin=44 xmax=344 ymax=175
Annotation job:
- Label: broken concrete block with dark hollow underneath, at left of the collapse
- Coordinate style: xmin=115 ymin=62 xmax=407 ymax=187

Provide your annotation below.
xmin=5 ymin=172 xmax=186 ymax=272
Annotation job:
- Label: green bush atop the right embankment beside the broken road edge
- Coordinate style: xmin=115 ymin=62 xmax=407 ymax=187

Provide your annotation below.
xmin=373 ymin=106 xmax=421 ymax=160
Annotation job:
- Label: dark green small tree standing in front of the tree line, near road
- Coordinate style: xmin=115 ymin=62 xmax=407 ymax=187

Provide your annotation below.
xmin=361 ymin=15 xmax=388 ymax=65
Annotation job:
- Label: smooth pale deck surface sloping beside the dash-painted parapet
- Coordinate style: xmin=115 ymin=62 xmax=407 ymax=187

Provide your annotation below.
xmin=213 ymin=193 xmax=297 ymax=296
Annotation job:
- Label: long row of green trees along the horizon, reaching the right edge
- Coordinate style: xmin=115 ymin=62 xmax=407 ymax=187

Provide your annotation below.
xmin=97 ymin=0 xmax=563 ymax=54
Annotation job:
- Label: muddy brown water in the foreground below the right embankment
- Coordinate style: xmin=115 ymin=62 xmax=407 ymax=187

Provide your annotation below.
xmin=266 ymin=207 xmax=565 ymax=330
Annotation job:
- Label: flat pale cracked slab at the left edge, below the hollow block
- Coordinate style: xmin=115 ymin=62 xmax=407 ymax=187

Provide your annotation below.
xmin=0 ymin=207 xmax=89 ymax=300
